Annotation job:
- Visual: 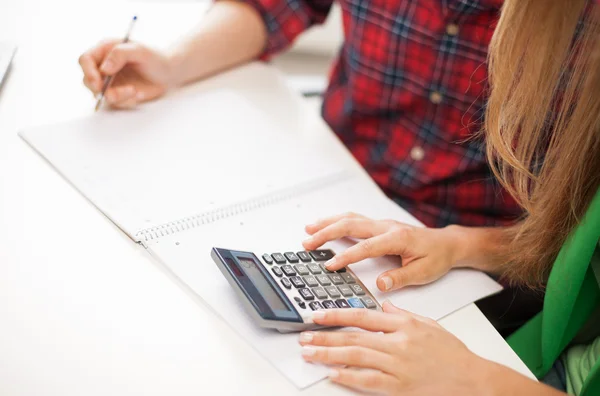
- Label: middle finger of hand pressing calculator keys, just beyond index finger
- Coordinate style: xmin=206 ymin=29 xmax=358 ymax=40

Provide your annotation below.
xmin=302 ymin=217 xmax=387 ymax=250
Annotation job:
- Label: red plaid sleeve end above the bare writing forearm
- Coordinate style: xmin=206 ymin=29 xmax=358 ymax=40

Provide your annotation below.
xmin=241 ymin=0 xmax=334 ymax=57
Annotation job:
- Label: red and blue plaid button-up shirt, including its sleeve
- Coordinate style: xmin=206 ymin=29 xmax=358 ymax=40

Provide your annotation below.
xmin=244 ymin=0 xmax=521 ymax=227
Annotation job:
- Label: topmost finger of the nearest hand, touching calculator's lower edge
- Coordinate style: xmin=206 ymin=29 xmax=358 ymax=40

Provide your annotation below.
xmin=313 ymin=308 xmax=400 ymax=333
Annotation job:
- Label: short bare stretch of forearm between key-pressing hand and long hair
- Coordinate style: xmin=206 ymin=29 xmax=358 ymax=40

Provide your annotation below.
xmin=444 ymin=224 xmax=519 ymax=275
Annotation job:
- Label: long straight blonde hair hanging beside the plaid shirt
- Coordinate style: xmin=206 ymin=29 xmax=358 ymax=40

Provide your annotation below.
xmin=485 ymin=0 xmax=600 ymax=286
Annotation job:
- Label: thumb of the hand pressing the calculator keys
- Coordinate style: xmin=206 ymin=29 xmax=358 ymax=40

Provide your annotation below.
xmin=377 ymin=259 xmax=447 ymax=291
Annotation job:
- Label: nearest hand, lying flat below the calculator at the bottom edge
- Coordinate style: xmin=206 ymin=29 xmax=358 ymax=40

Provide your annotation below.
xmin=300 ymin=302 xmax=495 ymax=395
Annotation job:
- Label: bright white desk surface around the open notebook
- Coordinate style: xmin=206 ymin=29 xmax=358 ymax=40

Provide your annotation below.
xmin=0 ymin=0 xmax=530 ymax=396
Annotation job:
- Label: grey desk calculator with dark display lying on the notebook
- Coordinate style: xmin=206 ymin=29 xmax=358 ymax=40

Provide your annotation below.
xmin=211 ymin=248 xmax=381 ymax=332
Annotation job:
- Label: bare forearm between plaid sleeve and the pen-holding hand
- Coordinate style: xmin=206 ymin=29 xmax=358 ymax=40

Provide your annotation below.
xmin=169 ymin=1 xmax=267 ymax=86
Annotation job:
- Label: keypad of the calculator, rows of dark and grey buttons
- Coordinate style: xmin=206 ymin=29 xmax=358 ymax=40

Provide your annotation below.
xmin=262 ymin=250 xmax=377 ymax=311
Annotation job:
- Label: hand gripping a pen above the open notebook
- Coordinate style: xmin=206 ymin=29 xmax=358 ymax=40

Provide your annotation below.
xmin=79 ymin=40 xmax=171 ymax=108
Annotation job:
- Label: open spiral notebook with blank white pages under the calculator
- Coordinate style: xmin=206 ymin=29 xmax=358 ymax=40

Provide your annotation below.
xmin=20 ymin=63 xmax=501 ymax=388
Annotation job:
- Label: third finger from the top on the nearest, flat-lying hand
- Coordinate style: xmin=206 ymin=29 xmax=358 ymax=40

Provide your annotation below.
xmin=302 ymin=345 xmax=396 ymax=373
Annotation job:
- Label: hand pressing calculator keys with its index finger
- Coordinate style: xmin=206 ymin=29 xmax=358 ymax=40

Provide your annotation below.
xmin=303 ymin=213 xmax=460 ymax=291
